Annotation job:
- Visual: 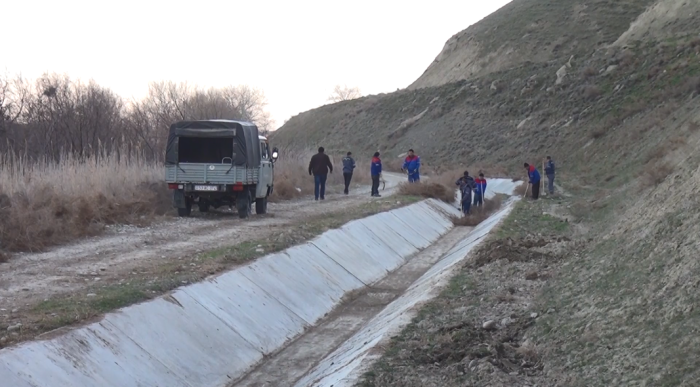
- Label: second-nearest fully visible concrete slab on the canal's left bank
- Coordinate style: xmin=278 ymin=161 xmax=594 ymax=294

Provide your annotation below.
xmin=182 ymin=271 xmax=308 ymax=354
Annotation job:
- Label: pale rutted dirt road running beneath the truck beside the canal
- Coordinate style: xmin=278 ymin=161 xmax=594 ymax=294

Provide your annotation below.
xmin=0 ymin=173 xmax=404 ymax=314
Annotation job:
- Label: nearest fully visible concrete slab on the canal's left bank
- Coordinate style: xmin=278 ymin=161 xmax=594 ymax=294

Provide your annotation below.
xmin=102 ymin=296 xmax=262 ymax=386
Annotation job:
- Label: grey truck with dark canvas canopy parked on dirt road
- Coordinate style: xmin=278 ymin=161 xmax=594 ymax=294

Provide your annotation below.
xmin=165 ymin=120 xmax=279 ymax=219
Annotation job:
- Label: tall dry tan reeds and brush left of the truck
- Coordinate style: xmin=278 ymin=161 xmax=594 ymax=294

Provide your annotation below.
xmin=0 ymin=153 xmax=171 ymax=251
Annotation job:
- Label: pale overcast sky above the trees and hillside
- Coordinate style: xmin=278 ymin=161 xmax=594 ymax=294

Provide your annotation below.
xmin=0 ymin=0 xmax=510 ymax=130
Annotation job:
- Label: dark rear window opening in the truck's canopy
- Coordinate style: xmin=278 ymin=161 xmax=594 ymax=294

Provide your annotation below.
xmin=177 ymin=137 xmax=233 ymax=164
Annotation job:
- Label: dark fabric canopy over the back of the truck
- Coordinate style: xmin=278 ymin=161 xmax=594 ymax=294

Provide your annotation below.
xmin=165 ymin=120 xmax=260 ymax=168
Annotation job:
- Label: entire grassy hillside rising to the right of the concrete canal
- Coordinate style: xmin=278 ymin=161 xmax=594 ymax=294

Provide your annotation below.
xmin=273 ymin=0 xmax=700 ymax=386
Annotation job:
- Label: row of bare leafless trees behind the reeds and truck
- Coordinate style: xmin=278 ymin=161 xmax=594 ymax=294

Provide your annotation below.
xmin=0 ymin=74 xmax=274 ymax=160
